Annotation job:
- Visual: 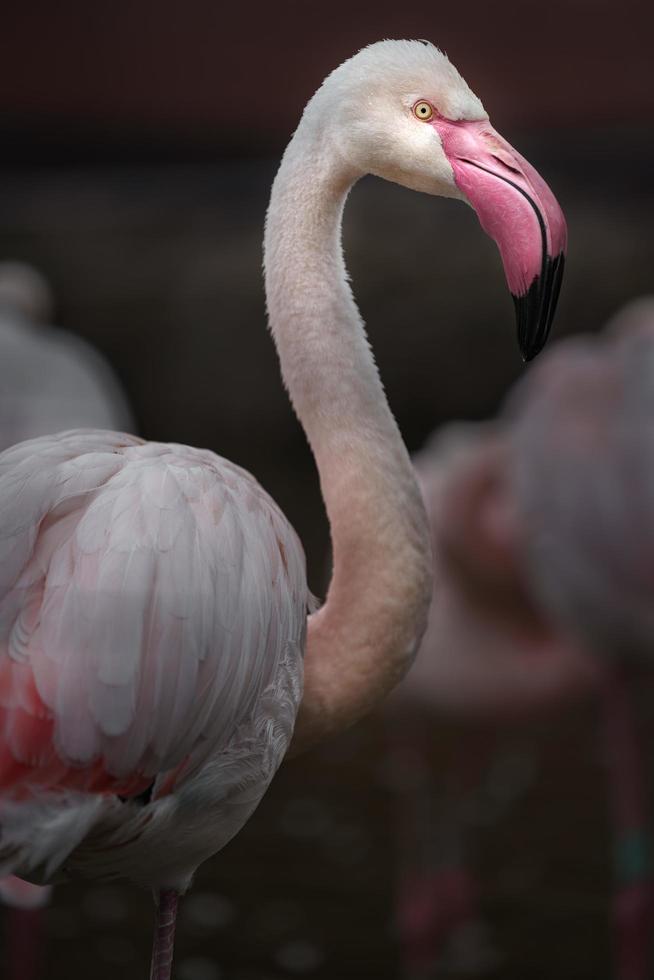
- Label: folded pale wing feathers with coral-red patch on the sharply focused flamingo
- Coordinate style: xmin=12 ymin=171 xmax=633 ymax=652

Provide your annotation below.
xmin=0 ymin=431 xmax=308 ymax=787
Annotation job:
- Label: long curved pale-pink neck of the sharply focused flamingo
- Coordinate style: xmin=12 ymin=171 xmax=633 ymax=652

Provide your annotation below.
xmin=265 ymin=126 xmax=431 ymax=747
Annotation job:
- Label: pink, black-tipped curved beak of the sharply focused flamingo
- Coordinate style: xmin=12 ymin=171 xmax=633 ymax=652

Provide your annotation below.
xmin=432 ymin=117 xmax=567 ymax=361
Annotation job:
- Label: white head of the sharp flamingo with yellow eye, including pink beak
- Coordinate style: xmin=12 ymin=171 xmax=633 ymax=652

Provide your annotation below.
xmin=314 ymin=41 xmax=567 ymax=360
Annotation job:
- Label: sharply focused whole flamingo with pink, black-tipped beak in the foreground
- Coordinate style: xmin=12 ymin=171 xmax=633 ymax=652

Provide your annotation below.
xmin=0 ymin=41 xmax=566 ymax=980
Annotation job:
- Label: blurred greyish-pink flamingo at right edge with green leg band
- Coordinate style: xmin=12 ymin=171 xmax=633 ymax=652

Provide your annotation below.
xmin=506 ymin=297 xmax=654 ymax=980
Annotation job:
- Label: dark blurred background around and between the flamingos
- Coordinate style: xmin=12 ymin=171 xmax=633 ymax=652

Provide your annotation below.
xmin=0 ymin=0 xmax=654 ymax=980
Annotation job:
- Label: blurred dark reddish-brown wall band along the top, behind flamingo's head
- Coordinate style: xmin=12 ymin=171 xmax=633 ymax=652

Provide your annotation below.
xmin=0 ymin=0 xmax=654 ymax=149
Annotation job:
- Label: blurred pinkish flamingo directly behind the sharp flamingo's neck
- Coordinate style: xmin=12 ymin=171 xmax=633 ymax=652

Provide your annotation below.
xmin=383 ymin=423 xmax=598 ymax=980
